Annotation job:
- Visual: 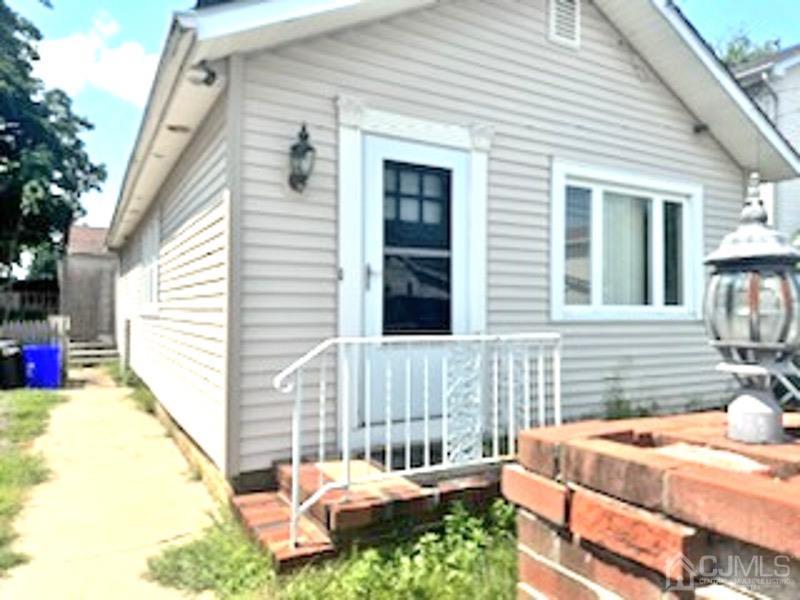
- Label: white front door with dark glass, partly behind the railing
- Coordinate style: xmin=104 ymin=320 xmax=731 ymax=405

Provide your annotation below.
xmin=354 ymin=135 xmax=469 ymax=443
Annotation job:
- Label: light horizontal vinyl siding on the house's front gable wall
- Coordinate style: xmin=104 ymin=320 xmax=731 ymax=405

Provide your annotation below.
xmin=233 ymin=0 xmax=743 ymax=471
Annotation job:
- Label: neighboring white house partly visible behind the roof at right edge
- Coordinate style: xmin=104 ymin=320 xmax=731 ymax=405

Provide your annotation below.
xmin=735 ymin=44 xmax=800 ymax=239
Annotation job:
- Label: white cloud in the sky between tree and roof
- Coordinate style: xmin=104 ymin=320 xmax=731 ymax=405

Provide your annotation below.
xmin=34 ymin=13 xmax=158 ymax=106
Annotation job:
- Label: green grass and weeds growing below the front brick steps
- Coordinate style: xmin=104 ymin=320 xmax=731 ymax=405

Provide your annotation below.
xmin=149 ymin=501 xmax=516 ymax=600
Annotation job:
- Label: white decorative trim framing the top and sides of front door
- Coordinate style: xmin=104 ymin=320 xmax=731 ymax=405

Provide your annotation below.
xmin=336 ymin=96 xmax=494 ymax=336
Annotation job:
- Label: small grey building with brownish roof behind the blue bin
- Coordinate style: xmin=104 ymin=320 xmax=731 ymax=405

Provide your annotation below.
xmin=58 ymin=225 xmax=117 ymax=342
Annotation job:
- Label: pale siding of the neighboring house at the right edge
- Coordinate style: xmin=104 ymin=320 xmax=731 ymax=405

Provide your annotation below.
xmin=773 ymin=67 xmax=800 ymax=238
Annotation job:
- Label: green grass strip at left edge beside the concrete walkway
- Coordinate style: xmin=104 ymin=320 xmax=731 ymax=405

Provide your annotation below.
xmin=0 ymin=390 xmax=61 ymax=575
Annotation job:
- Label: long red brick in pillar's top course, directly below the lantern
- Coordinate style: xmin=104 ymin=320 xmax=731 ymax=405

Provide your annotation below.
xmin=665 ymin=465 xmax=800 ymax=558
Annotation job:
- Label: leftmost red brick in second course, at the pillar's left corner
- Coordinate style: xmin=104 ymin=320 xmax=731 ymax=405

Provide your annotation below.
xmin=502 ymin=465 xmax=569 ymax=525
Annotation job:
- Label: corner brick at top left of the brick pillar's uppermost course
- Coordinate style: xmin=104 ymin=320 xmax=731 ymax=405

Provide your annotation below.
xmin=517 ymin=420 xmax=631 ymax=479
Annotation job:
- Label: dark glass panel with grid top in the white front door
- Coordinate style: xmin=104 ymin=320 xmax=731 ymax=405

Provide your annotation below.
xmin=383 ymin=161 xmax=451 ymax=335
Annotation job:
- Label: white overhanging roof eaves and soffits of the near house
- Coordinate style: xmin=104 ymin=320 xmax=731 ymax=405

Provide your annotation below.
xmin=108 ymin=0 xmax=800 ymax=247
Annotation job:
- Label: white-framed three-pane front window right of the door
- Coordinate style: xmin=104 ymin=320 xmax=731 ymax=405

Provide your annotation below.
xmin=552 ymin=161 xmax=702 ymax=319
